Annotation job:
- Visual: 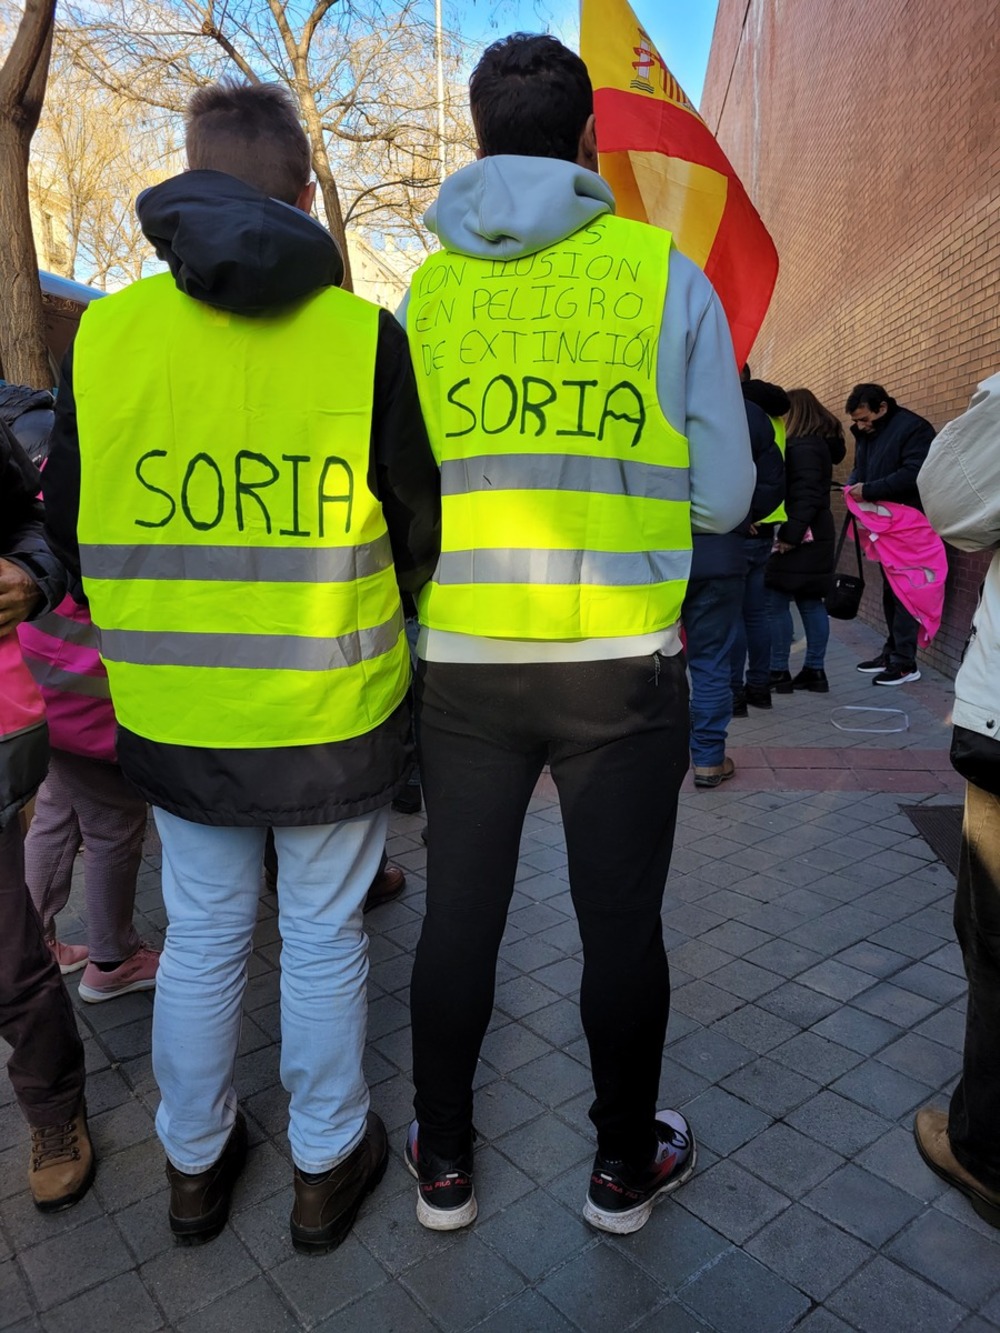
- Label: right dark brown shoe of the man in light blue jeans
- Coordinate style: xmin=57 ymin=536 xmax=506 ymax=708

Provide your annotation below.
xmin=292 ymin=1110 xmax=389 ymax=1254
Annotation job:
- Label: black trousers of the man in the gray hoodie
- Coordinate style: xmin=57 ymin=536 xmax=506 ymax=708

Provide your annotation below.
xmin=411 ymin=656 xmax=688 ymax=1162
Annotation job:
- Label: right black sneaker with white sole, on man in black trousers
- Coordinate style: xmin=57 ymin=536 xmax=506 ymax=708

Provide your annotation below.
xmin=584 ymin=1110 xmax=697 ymax=1236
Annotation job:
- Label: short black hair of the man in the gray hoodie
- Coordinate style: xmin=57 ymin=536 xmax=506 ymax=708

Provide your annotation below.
xmin=469 ymin=32 xmax=593 ymax=163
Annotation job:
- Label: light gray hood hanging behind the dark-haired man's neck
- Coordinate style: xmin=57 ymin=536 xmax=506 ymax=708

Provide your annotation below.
xmin=424 ymin=155 xmax=615 ymax=259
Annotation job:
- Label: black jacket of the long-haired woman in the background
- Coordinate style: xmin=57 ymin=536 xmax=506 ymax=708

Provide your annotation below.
xmin=764 ymin=435 xmax=847 ymax=597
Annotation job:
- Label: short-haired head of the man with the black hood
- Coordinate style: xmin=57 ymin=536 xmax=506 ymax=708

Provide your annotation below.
xmin=184 ymin=79 xmax=311 ymax=204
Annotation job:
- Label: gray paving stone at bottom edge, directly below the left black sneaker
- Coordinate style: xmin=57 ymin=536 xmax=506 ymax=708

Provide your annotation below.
xmin=401 ymin=1232 xmax=523 ymax=1329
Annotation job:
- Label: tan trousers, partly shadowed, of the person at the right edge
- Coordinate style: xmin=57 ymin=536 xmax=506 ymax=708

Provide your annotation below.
xmin=948 ymin=782 xmax=1000 ymax=1190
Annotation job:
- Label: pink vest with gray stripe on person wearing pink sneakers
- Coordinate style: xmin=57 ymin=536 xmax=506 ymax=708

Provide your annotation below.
xmin=17 ymin=597 xmax=116 ymax=764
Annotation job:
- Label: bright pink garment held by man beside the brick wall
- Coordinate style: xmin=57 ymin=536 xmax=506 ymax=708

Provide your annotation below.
xmin=844 ymin=492 xmax=948 ymax=648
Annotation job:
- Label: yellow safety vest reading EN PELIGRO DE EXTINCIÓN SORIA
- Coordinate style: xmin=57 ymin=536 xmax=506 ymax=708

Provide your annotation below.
xmin=407 ymin=216 xmax=691 ymax=641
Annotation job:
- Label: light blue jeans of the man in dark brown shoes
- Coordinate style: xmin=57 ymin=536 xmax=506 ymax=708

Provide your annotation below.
xmin=153 ymin=809 xmax=388 ymax=1172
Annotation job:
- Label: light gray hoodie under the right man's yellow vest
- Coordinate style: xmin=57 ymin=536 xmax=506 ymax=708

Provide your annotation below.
xmin=399 ymin=156 xmax=755 ymax=661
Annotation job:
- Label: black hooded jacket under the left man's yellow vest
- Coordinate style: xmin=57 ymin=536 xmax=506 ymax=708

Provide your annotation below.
xmin=45 ymin=171 xmax=440 ymax=826
